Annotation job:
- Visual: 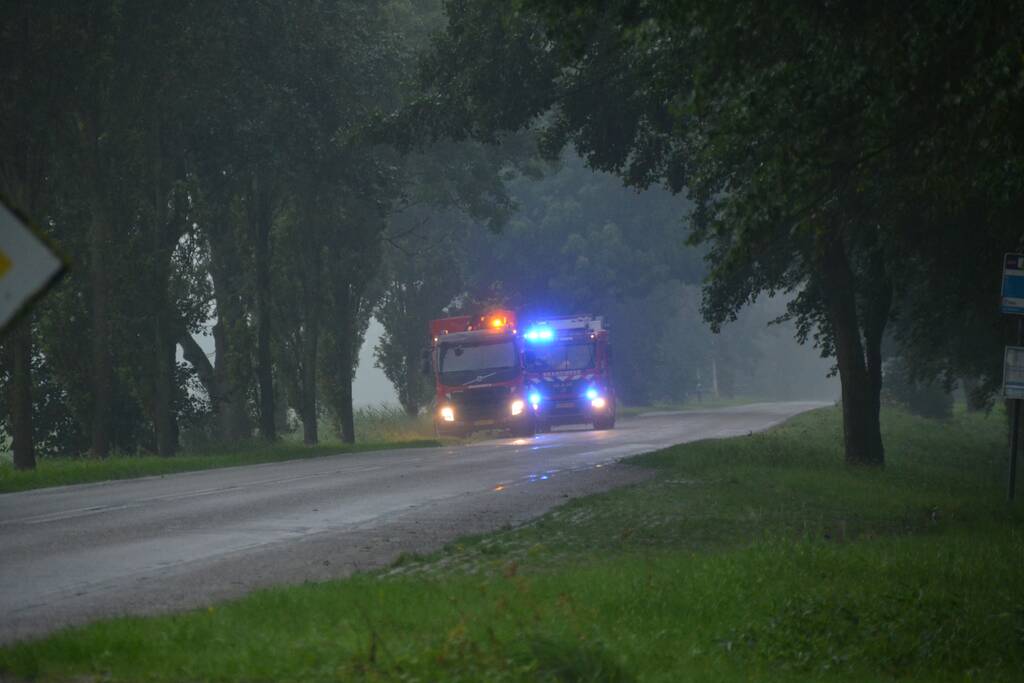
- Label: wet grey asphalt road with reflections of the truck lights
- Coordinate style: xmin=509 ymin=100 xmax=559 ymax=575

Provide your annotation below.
xmin=0 ymin=402 xmax=822 ymax=643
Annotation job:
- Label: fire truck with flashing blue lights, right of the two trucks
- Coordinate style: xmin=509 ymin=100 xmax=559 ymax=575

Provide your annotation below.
xmin=522 ymin=314 xmax=615 ymax=431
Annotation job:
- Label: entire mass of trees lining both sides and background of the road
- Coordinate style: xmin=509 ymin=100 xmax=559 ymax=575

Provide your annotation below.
xmin=8 ymin=0 xmax=1007 ymax=466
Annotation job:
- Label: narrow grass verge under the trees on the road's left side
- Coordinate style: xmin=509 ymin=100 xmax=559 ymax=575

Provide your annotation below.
xmin=0 ymin=407 xmax=441 ymax=494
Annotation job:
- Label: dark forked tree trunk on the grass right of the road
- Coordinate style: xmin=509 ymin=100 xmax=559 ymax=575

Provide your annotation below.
xmin=818 ymin=233 xmax=888 ymax=467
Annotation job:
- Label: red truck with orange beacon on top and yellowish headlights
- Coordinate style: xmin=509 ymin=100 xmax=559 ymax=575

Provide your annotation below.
xmin=430 ymin=310 xmax=535 ymax=436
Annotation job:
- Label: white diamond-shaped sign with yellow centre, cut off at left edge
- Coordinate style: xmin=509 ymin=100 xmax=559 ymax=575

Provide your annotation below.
xmin=0 ymin=204 xmax=63 ymax=330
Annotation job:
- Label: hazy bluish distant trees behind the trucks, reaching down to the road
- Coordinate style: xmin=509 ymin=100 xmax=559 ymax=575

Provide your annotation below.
xmin=452 ymin=154 xmax=833 ymax=404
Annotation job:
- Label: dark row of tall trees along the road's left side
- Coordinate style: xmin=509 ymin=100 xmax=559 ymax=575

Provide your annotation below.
xmin=0 ymin=0 xmax=516 ymax=467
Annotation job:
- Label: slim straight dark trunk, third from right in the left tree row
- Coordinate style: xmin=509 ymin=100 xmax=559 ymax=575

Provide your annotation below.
xmin=249 ymin=175 xmax=278 ymax=441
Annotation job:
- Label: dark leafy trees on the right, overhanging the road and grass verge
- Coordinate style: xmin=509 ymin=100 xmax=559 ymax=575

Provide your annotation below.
xmin=406 ymin=0 xmax=1024 ymax=465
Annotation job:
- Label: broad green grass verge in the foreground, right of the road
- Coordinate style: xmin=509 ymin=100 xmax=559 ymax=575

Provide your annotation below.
xmin=0 ymin=409 xmax=1024 ymax=681
